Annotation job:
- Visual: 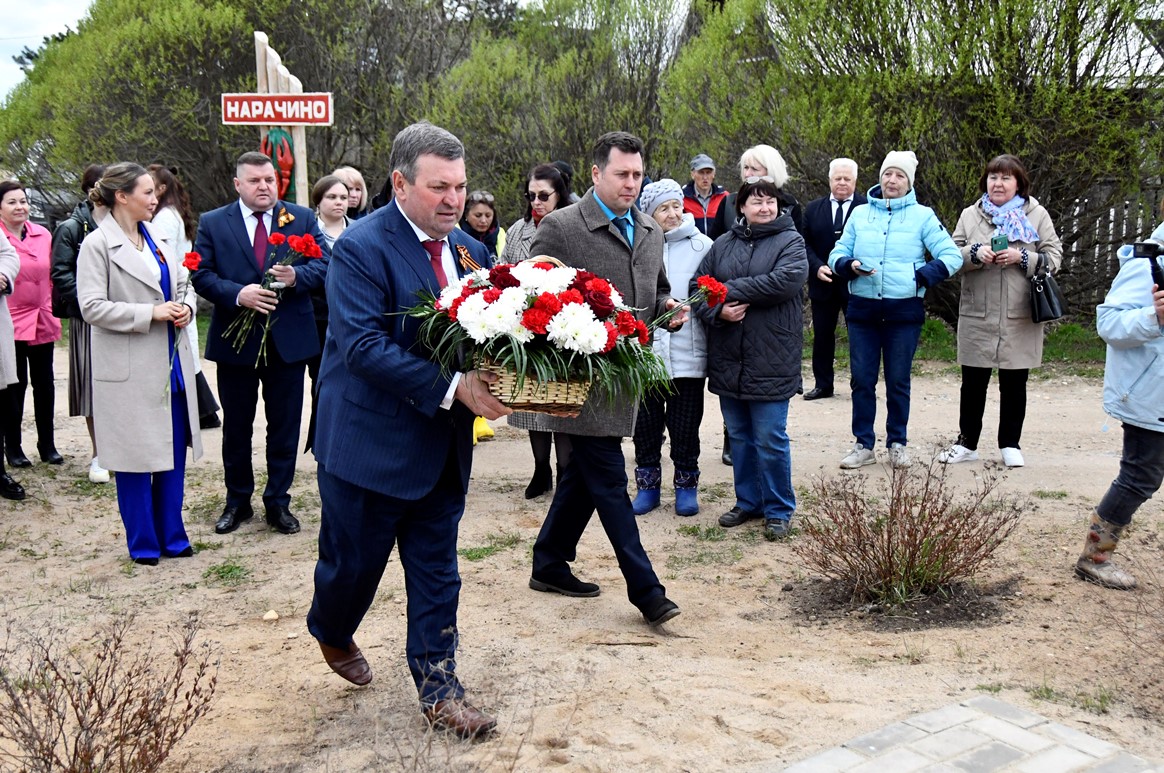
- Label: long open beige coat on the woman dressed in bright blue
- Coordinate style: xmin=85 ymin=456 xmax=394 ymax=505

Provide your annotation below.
xmin=77 ymin=215 xmax=203 ymax=473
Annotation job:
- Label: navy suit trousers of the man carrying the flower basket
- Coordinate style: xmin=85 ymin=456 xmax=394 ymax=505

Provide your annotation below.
xmin=307 ymin=452 xmax=464 ymax=707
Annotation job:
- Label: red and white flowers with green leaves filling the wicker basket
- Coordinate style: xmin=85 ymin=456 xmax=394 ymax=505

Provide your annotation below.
xmin=405 ymin=256 xmax=726 ymax=413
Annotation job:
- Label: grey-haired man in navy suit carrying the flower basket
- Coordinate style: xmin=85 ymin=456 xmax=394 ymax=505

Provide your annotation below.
xmin=307 ymin=123 xmax=511 ymax=737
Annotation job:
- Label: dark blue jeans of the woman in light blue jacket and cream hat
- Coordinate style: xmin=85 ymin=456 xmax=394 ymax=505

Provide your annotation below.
xmin=847 ymin=320 xmax=922 ymax=453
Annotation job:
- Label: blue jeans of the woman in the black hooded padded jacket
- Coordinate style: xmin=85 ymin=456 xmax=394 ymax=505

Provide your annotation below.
xmin=719 ymin=396 xmax=796 ymax=520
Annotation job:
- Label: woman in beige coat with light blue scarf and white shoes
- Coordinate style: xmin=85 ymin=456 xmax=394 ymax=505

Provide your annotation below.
xmin=938 ymin=155 xmax=1063 ymax=467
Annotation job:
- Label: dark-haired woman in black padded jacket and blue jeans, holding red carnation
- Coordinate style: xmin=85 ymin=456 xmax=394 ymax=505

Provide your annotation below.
xmin=691 ymin=176 xmax=808 ymax=539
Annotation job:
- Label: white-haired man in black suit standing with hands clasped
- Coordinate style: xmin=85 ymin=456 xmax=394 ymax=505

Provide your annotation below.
xmin=804 ymin=158 xmax=865 ymax=400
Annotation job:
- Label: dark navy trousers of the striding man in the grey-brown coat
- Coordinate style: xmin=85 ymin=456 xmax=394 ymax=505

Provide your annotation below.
xmin=533 ymin=434 xmax=666 ymax=610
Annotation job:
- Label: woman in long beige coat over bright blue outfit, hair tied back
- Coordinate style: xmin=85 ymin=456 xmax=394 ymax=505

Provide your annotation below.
xmin=77 ymin=163 xmax=203 ymax=566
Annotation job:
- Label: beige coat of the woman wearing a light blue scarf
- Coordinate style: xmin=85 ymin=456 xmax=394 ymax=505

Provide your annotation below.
xmin=953 ymin=197 xmax=1063 ymax=370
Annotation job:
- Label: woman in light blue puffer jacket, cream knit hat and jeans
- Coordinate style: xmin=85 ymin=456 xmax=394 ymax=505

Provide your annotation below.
xmin=829 ymin=150 xmax=961 ymax=469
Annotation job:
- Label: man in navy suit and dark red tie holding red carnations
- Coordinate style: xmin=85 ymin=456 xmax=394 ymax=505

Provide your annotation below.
xmin=193 ymin=153 xmax=328 ymax=534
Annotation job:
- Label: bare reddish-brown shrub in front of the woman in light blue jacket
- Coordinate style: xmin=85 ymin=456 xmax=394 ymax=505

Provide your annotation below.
xmin=799 ymin=460 xmax=1025 ymax=605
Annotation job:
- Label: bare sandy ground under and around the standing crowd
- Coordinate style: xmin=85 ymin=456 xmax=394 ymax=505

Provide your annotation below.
xmin=0 ymin=353 xmax=1164 ymax=771
